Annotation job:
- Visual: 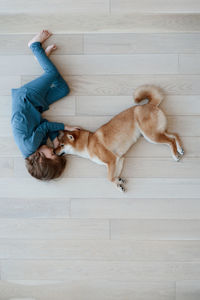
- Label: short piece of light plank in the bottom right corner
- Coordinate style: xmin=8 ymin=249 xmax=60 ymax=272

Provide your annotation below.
xmin=176 ymin=278 xmax=200 ymax=300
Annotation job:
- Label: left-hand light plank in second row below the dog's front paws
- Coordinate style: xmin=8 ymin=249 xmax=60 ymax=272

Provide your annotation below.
xmin=0 ymin=218 xmax=109 ymax=240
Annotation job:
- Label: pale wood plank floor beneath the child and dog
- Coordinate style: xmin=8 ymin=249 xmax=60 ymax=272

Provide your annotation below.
xmin=0 ymin=0 xmax=200 ymax=300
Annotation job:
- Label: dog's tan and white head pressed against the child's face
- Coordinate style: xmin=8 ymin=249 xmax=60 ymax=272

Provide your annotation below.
xmin=54 ymin=130 xmax=80 ymax=156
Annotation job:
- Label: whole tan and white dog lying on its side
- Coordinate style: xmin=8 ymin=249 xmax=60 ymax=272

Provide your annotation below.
xmin=56 ymin=85 xmax=184 ymax=191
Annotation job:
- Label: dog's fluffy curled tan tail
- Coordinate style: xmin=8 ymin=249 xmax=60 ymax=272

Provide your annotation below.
xmin=134 ymin=84 xmax=164 ymax=106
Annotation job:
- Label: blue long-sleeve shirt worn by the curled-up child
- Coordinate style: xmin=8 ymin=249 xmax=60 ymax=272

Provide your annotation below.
xmin=11 ymin=88 xmax=64 ymax=158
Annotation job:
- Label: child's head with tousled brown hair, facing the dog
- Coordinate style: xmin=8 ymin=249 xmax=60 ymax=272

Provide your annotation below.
xmin=26 ymin=145 xmax=66 ymax=180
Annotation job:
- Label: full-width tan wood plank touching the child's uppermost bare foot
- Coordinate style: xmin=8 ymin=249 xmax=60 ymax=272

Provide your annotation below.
xmin=0 ymin=12 xmax=200 ymax=34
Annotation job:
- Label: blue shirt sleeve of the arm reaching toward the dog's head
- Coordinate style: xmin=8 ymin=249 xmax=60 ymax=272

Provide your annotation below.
xmin=32 ymin=119 xmax=64 ymax=149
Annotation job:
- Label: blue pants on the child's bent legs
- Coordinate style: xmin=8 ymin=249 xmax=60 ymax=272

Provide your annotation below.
xmin=23 ymin=42 xmax=70 ymax=112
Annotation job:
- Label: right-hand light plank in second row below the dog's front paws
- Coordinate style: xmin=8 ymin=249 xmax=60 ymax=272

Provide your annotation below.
xmin=111 ymin=219 xmax=200 ymax=240
